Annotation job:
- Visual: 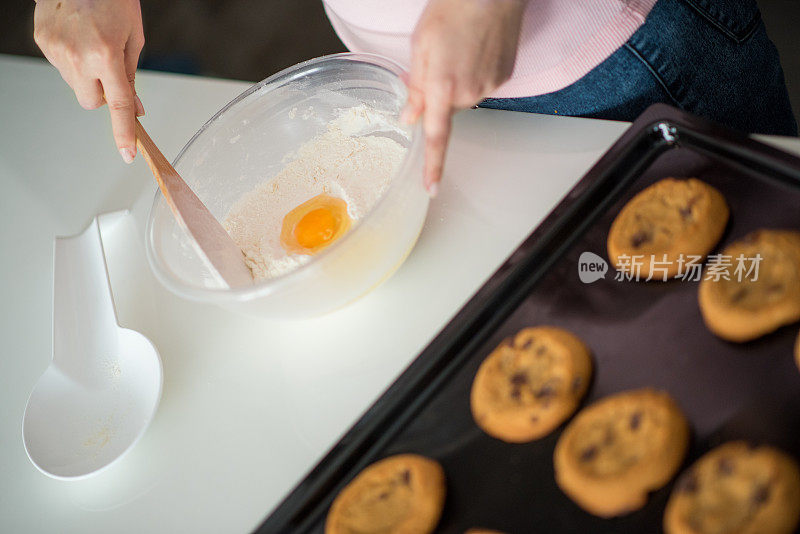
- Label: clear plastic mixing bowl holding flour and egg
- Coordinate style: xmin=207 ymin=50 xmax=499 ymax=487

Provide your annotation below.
xmin=146 ymin=54 xmax=428 ymax=319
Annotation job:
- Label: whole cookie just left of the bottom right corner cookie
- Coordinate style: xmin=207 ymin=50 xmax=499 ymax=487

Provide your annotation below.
xmin=553 ymin=388 xmax=689 ymax=517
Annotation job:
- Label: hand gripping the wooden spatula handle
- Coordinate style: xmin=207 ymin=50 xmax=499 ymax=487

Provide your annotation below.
xmin=33 ymin=0 xmax=144 ymax=163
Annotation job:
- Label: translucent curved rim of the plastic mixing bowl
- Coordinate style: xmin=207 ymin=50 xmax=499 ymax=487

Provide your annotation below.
xmin=145 ymin=52 xmax=422 ymax=303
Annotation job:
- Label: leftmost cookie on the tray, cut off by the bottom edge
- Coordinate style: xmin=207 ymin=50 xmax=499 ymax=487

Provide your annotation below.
xmin=325 ymin=454 xmax=445 ymax=534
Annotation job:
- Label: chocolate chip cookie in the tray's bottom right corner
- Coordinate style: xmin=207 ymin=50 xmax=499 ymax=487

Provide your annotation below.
xmin=664 ymin=441 xmax=800 ymax=534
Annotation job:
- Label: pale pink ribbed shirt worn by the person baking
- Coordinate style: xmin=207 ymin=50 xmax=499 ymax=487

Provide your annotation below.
xmin=323 ymin=0 xmax=656 ymax=98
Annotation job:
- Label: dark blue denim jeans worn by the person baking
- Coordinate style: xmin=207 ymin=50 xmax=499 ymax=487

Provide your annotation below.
xmin=480 ymin=0 xmax=797 ymax=135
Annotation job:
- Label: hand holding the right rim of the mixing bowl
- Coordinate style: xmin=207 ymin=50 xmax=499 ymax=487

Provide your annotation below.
xmin=402 ymin=0 xmax=526 ymax=196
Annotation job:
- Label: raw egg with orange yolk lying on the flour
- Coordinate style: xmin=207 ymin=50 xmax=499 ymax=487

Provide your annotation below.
xmin=281 ymin=193 xmax=350 ymax=254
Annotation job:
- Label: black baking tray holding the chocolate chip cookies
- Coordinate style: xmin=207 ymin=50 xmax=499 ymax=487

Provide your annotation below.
xmin=257 ymin=104 xmax=800 ymax=534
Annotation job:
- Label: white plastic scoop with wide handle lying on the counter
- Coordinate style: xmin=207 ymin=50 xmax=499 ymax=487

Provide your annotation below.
xmin=22 ymin=213 xmax=162 ymax=479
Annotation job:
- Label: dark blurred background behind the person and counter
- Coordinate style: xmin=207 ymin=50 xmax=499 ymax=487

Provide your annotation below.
xmin=0 ymin=0 xmax=800 ymax=126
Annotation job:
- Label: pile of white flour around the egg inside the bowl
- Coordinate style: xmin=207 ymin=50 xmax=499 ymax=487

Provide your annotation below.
xmin=223 ymin=105 xmax=406 ymax=280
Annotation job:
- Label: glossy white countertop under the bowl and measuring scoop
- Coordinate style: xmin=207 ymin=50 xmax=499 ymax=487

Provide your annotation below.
xmin=0 ymin=56 xmax=800 ymax=533
